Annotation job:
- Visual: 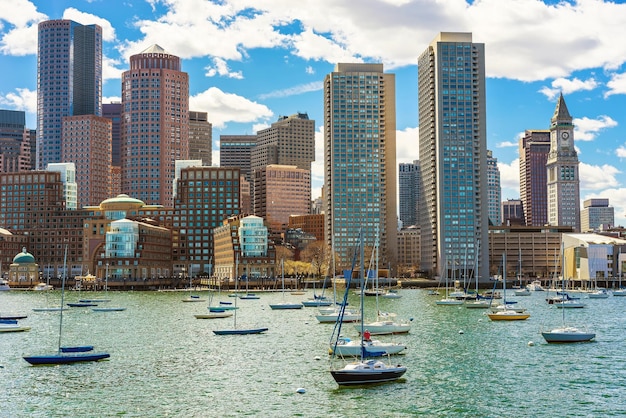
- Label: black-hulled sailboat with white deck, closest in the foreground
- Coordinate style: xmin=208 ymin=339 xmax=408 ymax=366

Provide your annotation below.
xmin=330 ymin=231 xmax=407 ymax=386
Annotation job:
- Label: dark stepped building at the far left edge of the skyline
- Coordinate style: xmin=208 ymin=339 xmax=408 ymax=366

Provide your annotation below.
xmin=0 ymin=109 xmax=31 ymax=173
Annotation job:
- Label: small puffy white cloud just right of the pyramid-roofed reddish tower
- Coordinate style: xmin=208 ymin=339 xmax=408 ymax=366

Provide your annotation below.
xmin=189 ymin=87 xmax=273 ymax=128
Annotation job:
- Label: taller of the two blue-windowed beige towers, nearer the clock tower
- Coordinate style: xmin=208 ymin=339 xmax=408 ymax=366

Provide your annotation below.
xmin=417 ymin=32 xmax=489 ymax=278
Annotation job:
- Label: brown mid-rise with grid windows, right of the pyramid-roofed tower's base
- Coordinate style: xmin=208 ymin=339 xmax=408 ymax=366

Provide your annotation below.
xmin=175 ymin=166 xmax=240 ymax=274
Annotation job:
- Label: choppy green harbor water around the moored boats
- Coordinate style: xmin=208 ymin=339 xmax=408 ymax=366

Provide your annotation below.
xmin=0 ymin=290 xmax=626 ymax=417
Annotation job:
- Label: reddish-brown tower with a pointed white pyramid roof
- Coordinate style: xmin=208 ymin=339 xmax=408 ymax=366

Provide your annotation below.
xmin=121 ymin=45 xmax=189 ymax=207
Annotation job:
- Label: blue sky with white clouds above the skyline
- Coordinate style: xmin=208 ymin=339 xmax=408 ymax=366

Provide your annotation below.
xmin=0 ymin=0 xmax=626 ymax=226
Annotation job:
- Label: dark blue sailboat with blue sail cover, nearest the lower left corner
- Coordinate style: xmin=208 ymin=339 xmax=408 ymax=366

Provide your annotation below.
xmin=23 ymin=244 xmax=111 ymax=365
